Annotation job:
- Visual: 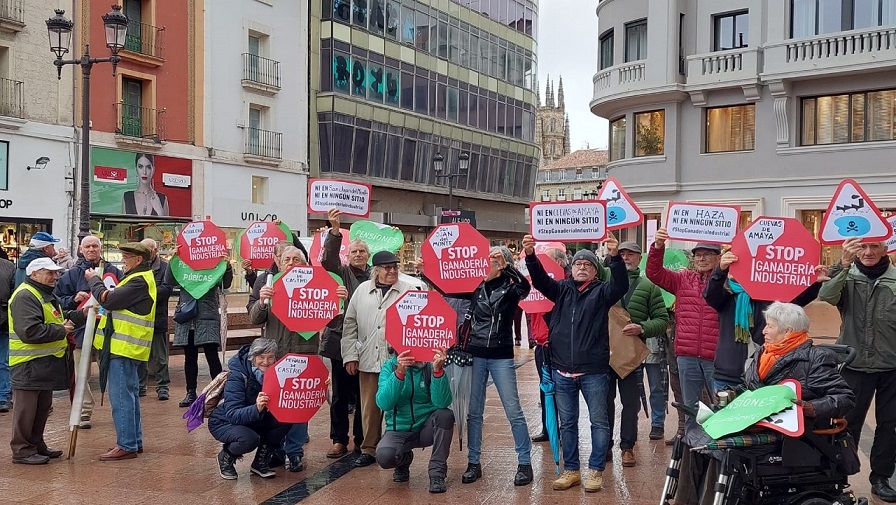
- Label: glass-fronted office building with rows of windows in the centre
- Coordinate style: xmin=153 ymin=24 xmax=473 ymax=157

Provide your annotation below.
xmin=309 ymin=0 xmax=539 ymax=268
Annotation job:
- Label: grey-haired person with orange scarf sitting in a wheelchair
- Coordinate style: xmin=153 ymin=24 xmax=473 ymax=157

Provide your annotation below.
xmin=663 ymin=302 xmax=858 ymax=505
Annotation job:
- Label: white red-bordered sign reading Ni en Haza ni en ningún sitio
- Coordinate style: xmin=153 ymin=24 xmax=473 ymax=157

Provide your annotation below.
xmin=666 ymin=202 xmax=740 ymax=244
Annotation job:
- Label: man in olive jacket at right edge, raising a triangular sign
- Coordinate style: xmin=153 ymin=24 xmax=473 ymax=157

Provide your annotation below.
xmin=818 ymin=238 xmax=896 ymax=503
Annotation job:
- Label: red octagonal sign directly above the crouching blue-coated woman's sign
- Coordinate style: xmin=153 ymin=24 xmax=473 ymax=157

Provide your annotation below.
xmin=271 ymin=266 xmax=339 ymax=332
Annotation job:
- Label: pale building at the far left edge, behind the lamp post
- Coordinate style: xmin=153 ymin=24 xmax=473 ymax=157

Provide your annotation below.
xmin=0 ymin=0 xmax=77 ymax=260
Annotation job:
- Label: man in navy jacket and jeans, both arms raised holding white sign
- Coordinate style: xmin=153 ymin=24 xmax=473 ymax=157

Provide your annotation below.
xmin=522 ymin=235 xmax=629 ymax=493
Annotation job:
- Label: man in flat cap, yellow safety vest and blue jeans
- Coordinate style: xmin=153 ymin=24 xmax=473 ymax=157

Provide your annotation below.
xmin=84 ymin=242 xmax=156 ymax=461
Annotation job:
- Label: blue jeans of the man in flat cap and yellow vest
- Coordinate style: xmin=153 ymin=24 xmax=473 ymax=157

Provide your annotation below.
xmin=107 ymin=356 xmax=143 ymax=451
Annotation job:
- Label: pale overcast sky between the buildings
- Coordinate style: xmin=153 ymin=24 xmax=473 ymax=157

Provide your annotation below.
xmin=538 ymin=0 xmax=608 ymax=151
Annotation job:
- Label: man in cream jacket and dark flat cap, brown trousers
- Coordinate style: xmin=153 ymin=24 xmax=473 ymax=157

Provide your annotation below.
xmin=341 ymin=251 xmax=420 ymax=467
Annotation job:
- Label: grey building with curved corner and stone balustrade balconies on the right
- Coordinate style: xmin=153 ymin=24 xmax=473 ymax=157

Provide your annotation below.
xmin=591 ymin=0 xmax=896 ymax=262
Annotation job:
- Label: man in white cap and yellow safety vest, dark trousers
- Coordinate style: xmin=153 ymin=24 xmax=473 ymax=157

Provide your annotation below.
xmin=9 ymin=258 xmax=85 ymax=465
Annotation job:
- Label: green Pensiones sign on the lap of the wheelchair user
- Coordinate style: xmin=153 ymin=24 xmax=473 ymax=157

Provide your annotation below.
xmin=703 ymin=385 xmax=796 ymax=440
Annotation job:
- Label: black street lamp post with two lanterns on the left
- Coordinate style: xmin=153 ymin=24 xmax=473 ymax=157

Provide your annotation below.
xmin=47 ymin=5 xmax=128 ymax=242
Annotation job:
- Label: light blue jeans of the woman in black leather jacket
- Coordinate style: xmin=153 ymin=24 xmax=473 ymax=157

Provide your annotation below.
xmin=467 ymin=358 xmax=532 ymax=465
